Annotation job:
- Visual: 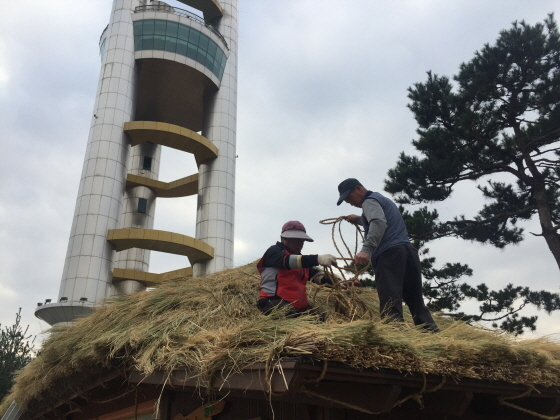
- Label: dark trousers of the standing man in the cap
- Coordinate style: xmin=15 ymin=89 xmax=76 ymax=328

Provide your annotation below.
xmin=373 ymin=244 xmax=439 ymax=332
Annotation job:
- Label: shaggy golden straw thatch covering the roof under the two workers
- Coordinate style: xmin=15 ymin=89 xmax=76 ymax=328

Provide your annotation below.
xmin=0 ymin=263 xmax=560 ymax=413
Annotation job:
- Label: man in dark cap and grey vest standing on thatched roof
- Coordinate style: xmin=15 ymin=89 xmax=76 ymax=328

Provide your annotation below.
xmin=337 ymin=178 xmax=439 ymax=332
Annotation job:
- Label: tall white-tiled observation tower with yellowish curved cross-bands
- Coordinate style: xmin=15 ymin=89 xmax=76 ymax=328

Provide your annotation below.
xmin=35 ymin=0 xmax=237 ymax=325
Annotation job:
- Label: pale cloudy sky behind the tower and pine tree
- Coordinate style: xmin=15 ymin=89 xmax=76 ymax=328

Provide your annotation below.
xmin=0 ymin=0 xmax=560 ymax=340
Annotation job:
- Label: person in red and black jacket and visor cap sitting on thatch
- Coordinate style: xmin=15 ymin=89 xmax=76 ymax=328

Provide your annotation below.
xmin=257 ymin=220 xmax=336 ymax=317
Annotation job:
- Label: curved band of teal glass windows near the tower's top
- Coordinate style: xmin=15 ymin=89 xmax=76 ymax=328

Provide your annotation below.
xmin=134 ymin=19 xmax=227 ymax=80
